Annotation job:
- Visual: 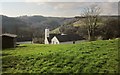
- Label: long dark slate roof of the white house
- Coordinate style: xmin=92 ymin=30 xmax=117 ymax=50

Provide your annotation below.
xmin=48 ymin=34 xmax=84 ymax=42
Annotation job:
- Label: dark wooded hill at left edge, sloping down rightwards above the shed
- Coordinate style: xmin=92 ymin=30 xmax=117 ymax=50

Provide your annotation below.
xmin=0 ymin=15 xmax=27 ymax=33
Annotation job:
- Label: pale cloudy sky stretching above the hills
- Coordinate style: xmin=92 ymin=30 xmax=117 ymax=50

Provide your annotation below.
xmin=2 ymin=2 xmax=118 ymax=17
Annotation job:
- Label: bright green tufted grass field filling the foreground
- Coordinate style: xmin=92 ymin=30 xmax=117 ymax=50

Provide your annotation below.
xmin=2 ymin=40 xmax=119 ymax=73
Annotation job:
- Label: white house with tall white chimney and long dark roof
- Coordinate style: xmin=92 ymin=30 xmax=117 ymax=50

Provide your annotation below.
xmin=44 ymin=29 xmax=84 ymax=44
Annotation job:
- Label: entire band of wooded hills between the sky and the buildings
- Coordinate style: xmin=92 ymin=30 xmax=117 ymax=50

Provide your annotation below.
xmin=0 ymin=15 xmax=120 ymax=41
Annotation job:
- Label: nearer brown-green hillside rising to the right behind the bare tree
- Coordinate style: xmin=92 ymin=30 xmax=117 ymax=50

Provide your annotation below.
xmin=51 ymin=16 xmax=120 ymax=40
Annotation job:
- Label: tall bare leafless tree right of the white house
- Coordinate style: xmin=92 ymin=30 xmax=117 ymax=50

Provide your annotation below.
xmin=81 ymin=5 xmax=101 ymax=41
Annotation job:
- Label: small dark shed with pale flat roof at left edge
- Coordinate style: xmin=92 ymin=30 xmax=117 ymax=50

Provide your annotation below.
xmin=0 ymin=34 xmax=17 ymax=49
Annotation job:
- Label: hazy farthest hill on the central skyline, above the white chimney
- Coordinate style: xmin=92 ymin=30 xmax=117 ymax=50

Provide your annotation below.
xmin=18 ymin=15 xmax=71 ymax=29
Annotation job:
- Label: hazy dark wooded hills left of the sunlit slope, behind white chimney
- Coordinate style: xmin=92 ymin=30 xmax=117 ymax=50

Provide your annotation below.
xmin=0 ymin=15 xmax=72 ymax=37
